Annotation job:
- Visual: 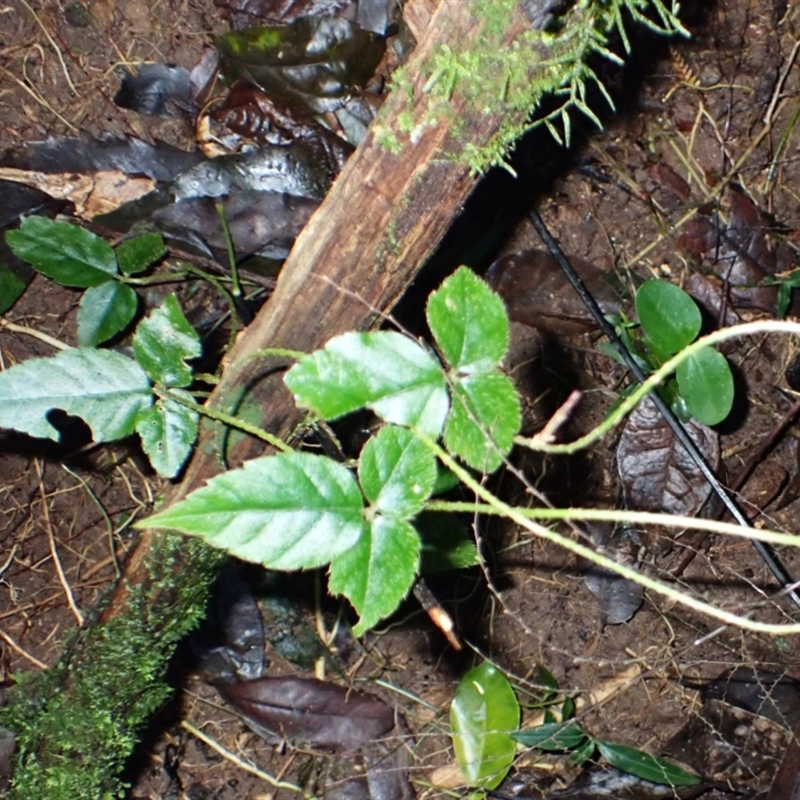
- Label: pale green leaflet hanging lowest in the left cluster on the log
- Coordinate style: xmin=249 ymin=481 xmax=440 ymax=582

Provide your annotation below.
xmin=136 ymin=389 xmax=199 ymax=478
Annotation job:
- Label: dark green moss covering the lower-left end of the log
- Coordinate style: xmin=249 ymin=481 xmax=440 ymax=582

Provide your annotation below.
xmin=0 ymin=536 xmax=224 ymax=800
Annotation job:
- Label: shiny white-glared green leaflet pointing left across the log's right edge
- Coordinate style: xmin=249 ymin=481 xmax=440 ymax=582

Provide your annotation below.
xmin=284 ymin=331 xmax=448 ymax=438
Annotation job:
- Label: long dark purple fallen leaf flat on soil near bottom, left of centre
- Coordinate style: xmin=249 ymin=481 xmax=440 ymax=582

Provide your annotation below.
xmin=219 ymin=678 xmax=395 ymax=750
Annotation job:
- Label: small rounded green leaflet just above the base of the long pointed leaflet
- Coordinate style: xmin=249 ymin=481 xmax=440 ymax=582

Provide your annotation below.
xmin=358 ymin=425 xmax=436 ymax=519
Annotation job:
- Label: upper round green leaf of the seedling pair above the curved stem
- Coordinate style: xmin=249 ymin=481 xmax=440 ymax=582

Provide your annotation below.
xmin=636 ymin=280 xmax=702 ymax=358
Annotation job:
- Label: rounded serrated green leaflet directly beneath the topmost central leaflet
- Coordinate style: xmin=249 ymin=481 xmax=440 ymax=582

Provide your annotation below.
xmin=444 ymin=372 xmax=521 ymax=473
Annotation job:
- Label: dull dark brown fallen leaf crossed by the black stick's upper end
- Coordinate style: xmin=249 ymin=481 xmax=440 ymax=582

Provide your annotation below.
xmin=486 ymin=250 xmax=621 ymax=336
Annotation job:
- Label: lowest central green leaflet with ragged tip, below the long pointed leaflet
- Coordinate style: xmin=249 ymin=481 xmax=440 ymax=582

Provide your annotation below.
xmin=328 ymin=515 xmax=419 ymax=636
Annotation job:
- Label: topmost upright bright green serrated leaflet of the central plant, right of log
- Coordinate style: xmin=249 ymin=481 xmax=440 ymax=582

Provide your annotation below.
xmin=426 ymin=267 xmax=508 ymax=374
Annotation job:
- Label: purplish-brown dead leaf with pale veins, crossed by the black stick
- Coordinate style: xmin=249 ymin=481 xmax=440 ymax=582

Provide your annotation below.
xmin=617 ymin=397 xmax=719 ymax=516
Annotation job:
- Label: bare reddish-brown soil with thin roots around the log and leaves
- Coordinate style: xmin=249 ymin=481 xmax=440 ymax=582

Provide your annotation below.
xmin=0 ymin=0 xmax=800 ymax=800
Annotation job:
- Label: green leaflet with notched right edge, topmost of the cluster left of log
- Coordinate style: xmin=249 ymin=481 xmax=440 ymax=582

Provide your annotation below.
xmin=133 ymin=295 xmax=203 ymax=387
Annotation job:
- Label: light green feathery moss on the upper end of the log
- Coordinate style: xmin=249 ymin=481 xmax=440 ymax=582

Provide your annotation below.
xmin=387 ymin=0 xmax=685 ymax=173
